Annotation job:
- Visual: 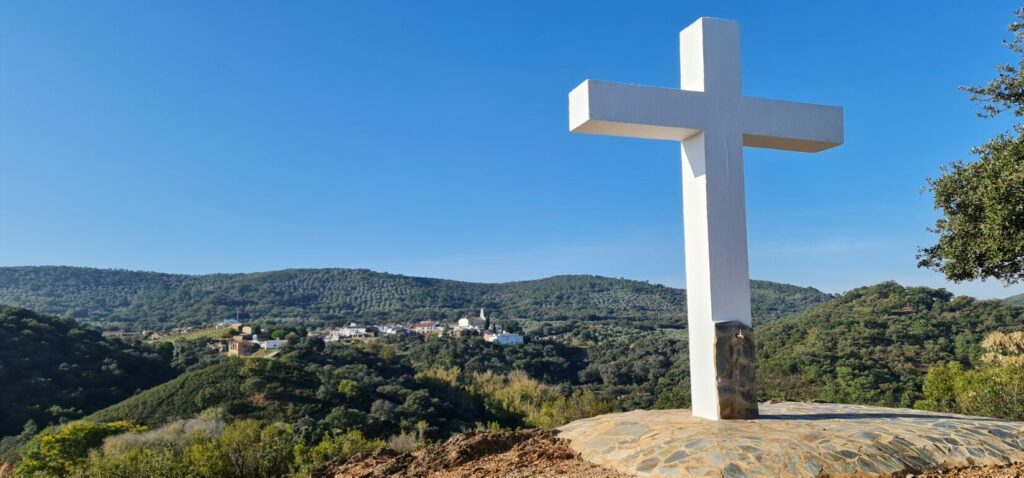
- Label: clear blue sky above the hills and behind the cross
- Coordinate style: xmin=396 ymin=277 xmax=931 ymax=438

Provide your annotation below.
xmin=0 ymin=0 xmax=1024 ymax=297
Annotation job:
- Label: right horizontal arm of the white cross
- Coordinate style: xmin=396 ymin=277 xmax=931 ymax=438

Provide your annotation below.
xmin=742 ymin=96 xmax=843 ymax=153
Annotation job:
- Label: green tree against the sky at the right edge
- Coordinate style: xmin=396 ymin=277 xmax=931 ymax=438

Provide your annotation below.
xmin=918 ymin=8 xmax=1024 ymax=285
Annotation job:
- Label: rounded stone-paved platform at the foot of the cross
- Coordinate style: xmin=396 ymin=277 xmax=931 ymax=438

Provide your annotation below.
xmin=559 ymin=402 xmax=1024 ymax=478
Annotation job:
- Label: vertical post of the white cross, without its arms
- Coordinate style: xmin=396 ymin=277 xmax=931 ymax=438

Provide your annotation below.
xmin=679 ymin=18 xmax=757 ymax=419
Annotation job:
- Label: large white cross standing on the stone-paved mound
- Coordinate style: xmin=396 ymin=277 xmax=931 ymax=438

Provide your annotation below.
xmin=569 ymin=17 xmax=843 ymax=420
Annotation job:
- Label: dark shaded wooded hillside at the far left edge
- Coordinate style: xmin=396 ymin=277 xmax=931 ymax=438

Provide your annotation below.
xmin=0 ymin=306 xmax=174 ymax=436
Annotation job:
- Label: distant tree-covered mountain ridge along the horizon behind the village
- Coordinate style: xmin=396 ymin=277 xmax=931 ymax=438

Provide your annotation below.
xmin=0 ymin=266 xmax=833 ymax=324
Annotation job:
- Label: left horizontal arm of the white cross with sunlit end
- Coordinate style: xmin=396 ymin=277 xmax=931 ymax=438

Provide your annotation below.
xmin=569 ymin=80 xmax=706 ymax=141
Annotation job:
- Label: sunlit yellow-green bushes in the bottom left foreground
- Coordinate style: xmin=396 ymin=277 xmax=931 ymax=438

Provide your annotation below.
xmin=16 ymin=414 xmax=385 ymax=478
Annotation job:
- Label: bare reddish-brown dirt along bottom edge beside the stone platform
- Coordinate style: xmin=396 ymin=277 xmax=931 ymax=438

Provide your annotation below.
xmin=313 ymin=430 xmax=1024 ymax=478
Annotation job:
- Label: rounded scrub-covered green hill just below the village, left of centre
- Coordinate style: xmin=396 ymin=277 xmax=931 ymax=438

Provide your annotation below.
xmin=85 ymin=338 xmax=524 ymax=437
